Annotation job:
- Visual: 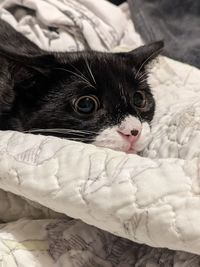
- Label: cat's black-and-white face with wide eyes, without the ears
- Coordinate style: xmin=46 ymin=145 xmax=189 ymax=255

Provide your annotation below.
xmin=16 ymin=52 xmax=155 ymax=152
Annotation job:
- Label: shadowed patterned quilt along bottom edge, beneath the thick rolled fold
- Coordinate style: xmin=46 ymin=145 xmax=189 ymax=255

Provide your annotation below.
xmin=0 ymin=219 xmax=200 ymax=267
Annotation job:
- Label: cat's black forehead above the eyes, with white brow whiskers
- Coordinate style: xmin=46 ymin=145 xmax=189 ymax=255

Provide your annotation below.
xmin=52 ymin=51 xmax=149 ymax=103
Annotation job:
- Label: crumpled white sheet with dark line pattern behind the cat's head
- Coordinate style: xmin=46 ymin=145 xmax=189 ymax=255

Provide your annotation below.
xmin=0 ymin=0 xmax=127 ymax=51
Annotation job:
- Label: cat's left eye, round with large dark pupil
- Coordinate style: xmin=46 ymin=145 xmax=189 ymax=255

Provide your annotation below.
xmin=74 ymin=95 xmax=100 ymax=115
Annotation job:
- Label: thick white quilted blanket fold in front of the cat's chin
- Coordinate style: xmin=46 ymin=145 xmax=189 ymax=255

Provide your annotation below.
xmin=0 ymin=125 xmax=200 ymax=254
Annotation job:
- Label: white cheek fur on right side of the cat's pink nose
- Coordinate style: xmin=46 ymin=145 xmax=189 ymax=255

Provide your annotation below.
xmin=133 ymin=122 xmax=152 ymax=153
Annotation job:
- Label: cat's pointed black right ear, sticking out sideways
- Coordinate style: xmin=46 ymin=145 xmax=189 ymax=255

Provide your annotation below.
xmin=119 ymin=41 xmax=164 ymax=69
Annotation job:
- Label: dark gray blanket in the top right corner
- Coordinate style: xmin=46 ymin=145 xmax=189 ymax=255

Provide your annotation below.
xmin=128 ymin=0 xmax=200 ymax=68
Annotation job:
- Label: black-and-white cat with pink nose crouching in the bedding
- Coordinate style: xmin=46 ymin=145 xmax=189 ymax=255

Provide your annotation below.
xmin=0 ymin=20 xmax=163 ymax=153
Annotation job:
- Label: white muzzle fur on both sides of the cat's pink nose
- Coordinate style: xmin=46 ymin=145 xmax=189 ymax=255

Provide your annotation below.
xmin=93 ymin=122 xmax=151 ymax=153
